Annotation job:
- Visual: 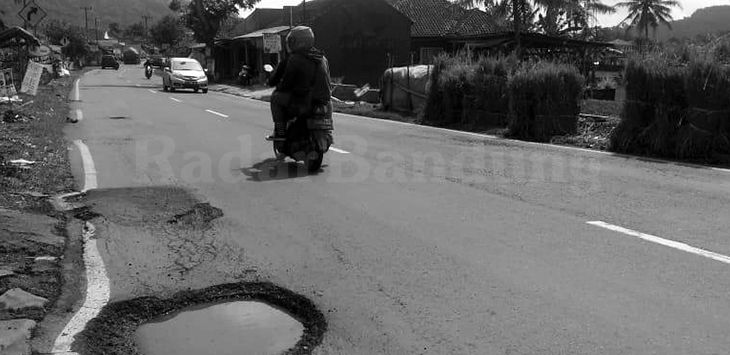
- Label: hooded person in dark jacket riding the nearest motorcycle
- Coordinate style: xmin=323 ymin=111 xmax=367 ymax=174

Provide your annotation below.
xmin=267 ymin=26 xmax=332 ymax=144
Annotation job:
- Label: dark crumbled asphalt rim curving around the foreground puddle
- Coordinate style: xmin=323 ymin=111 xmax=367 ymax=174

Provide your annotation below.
xmin=73 ymin=283 xmax=327 ymax=355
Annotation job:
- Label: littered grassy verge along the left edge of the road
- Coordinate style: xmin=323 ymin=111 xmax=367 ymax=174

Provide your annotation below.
xmin=0 ymin=73 xmax=78 ymax=212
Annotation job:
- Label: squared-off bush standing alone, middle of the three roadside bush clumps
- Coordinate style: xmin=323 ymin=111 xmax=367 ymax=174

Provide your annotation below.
xmin=508 ymin=62 xmax=584 ymax=142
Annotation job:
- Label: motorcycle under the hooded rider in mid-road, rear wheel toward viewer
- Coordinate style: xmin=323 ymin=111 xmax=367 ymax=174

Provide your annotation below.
xmin=266 ymin=105 xmax=333 ymax=173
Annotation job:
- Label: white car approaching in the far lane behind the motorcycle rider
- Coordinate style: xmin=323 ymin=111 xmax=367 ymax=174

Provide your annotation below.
xmin=162 ymin=58 xmax=208 ymax=94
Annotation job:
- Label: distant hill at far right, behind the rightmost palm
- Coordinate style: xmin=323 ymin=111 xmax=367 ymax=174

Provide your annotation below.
xmin=657 ymin=6 xmax=730 ymax=41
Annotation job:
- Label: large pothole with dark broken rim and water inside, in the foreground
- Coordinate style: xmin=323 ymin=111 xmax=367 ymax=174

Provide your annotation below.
xmin=72 ymin=282 xmax=327 ymax=355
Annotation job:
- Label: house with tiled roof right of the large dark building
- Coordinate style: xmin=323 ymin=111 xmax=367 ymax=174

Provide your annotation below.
xmin=391 ymin=0 xmax=502 ymax=64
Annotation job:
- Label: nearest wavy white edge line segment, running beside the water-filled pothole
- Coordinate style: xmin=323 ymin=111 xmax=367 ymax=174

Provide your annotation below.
xmin=51 ymin=222 xmax=110 ymax=355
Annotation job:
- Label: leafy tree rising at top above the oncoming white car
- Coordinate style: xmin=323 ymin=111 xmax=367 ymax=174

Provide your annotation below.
xmin=183 ymin=0 xmax=259 ymax=47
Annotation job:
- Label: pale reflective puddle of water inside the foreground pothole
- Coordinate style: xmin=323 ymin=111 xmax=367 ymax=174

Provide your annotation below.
xmin=134 ymin=301 xmax=304 ymax=355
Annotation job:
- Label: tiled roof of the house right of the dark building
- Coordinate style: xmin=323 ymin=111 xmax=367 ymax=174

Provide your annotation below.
xmin=391 ymin=0 xmax=499 ymax=37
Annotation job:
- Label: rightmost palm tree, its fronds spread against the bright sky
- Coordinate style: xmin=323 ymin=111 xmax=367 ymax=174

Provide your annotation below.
xmin=616 ymin=0 xmax=682 ymax=39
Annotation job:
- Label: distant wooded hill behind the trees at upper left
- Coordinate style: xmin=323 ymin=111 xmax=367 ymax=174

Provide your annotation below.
xmin=0 ymin=0 xmax=172 ymax=27
